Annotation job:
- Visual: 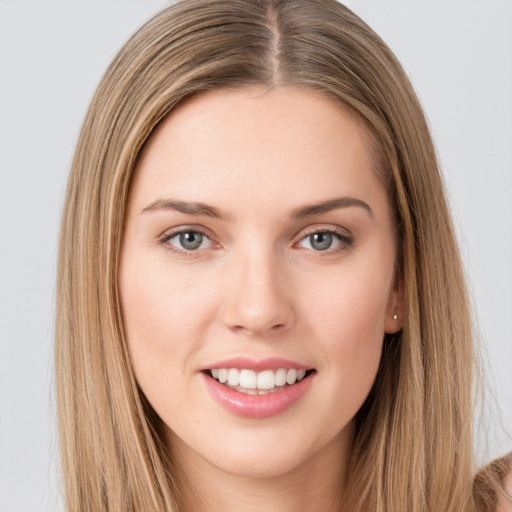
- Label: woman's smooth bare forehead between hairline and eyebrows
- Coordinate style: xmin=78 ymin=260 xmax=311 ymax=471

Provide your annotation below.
xmin=132 ymin=87 xmax=383 ymax=216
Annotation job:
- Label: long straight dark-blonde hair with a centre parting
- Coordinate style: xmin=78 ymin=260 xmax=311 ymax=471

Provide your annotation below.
xmin=55 ymin=0 xmax=508 ymax=512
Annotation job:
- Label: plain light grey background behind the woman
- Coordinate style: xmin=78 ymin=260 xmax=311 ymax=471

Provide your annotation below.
xmin=0 ymin=0 xmax=512 ymax=512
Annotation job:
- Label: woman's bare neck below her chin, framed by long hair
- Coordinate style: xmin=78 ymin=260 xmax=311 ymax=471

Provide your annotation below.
xmin=168 ymin=428 xmax=352 ymax=512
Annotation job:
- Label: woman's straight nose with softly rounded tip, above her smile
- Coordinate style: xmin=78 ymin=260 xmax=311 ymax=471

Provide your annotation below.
xmin=222 ymin=247 xmax=295 ymax=336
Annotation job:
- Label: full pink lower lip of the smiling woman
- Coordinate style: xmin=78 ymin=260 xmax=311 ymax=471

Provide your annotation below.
xmin=203 ymin=374 xmax=314 ymax=418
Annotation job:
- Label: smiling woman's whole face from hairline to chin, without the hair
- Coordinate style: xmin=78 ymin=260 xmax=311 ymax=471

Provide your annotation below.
xmin=120 ymin=87 xmax=400 ymax=476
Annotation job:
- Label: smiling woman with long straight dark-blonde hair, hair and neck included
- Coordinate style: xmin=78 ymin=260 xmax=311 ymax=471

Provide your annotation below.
xmin=56 ymin=0 xmax=509 ymax=511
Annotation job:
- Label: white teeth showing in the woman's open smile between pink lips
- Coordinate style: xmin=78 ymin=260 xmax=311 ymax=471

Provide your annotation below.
xmin=205 ymin=368 xmax=315 ymax=395
